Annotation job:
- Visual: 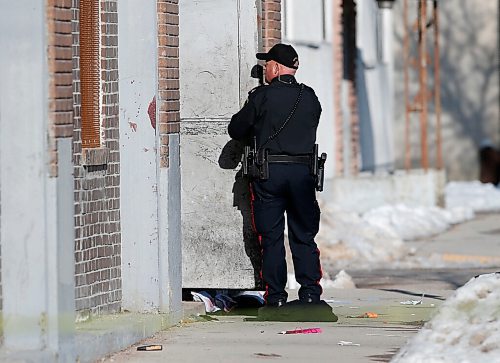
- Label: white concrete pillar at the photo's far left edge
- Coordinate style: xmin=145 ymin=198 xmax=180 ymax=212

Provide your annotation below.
xmin=0 ymin=0 xmax=75 ymax=361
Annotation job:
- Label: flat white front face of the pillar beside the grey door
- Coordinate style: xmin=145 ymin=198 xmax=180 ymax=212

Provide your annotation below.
xmin=118 ymin=0 xmax=160 ymax=312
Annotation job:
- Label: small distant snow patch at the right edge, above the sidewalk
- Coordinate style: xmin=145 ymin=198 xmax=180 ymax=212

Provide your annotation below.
xmin=445 ymin=181 xmax=500 ymax=212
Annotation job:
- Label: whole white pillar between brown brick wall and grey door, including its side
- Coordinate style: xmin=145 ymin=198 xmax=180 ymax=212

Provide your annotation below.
xmin=118 ymin=0 xmax=182 ymax=322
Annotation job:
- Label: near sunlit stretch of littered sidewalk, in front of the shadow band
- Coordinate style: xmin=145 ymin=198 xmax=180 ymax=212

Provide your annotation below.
xmin=99 ymin=289 xmax=451 ymax=363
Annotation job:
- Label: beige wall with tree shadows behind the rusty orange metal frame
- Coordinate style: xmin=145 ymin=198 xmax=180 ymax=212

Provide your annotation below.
xmin=394 ymin=0 xmax=500 ymax=180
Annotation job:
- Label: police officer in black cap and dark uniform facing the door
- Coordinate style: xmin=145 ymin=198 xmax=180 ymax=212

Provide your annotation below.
xmin=228 ymin=44 xmax=322 ymax=307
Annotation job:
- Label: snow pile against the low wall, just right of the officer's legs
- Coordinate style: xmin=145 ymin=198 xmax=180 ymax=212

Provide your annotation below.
xmin=316 ymin=202 xmax=474 ymax=267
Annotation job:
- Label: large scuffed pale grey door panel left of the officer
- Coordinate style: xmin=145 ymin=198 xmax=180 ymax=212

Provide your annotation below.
xmin=180 ymin=0 xmax=260 ymax=288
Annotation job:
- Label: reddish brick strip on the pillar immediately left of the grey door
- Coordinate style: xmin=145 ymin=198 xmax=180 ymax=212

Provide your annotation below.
xmin=154 ymin=0 xmax=180 ymax=168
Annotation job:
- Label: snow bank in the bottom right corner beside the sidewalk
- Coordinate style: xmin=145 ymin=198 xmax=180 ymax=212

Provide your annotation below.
xmin=391 ymin=273 xmax=500 ymax=363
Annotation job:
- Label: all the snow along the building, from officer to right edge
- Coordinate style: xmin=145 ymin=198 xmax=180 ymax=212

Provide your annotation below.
xmin=316 ymin=181 xmax=500 ymax=268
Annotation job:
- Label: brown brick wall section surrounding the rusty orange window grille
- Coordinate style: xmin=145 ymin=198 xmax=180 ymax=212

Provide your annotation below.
xmin=72 ymin=0 xmax=121 ymax=316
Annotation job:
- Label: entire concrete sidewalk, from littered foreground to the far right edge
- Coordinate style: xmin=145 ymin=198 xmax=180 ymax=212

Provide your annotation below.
xmin=100 ymin=214 xmax=500 ymax=363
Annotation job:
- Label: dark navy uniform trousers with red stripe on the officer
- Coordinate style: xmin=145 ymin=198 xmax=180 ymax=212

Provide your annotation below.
xmin=253 ymin=163 xmax=322 ymax=304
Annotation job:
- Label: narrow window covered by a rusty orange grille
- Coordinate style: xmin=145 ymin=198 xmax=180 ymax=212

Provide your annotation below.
xmin=79 ymin=0 xmax=101 ymax=148
